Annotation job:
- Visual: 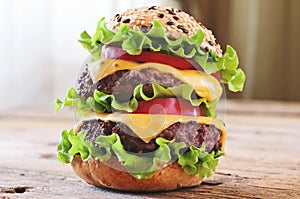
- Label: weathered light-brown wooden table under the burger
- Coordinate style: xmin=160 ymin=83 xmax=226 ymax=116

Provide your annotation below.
xmin=0 ymin=100 xmax=300 ymax=199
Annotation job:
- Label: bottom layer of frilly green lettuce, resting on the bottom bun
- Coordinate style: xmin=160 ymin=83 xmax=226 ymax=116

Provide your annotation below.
xmin=57 ymin=130 xmax=224 ymax=179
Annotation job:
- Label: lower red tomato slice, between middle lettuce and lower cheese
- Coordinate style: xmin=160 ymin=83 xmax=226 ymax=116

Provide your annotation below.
xmin=133 ymin=98 xmax=205 ymax=116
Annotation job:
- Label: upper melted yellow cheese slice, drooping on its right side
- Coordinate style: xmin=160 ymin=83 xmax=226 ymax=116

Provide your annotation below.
xmin=89 ymin=59 xmax=222 ymax=101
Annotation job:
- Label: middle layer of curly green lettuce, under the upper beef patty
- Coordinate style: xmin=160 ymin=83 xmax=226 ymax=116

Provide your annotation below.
xmin=55 ymin=84 xmax=217 ymax=118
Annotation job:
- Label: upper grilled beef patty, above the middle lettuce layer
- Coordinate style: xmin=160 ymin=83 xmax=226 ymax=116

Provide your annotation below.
xmin=76 ymin=66 xmax=182 ymax=102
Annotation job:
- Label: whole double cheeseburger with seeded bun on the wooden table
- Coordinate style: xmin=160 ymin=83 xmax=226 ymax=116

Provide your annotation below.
xmin=55 ymin=6 xmax=245 ymax=191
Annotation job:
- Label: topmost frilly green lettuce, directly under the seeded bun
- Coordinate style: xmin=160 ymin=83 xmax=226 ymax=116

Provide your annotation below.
xmin=78 ymin=18 xmax=245 ymax=92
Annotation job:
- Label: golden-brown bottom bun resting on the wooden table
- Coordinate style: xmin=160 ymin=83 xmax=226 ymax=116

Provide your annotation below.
xmin=72 ymin=155 xmax=202 ymax=191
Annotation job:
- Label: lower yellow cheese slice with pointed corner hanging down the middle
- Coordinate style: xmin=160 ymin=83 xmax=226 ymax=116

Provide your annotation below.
xmin=75 ymin=113 xmax=226 ymax=150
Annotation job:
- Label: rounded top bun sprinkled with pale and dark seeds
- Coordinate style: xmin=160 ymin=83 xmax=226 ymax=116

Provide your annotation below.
xmin=107 ymin=6 xmax=222 ymax=57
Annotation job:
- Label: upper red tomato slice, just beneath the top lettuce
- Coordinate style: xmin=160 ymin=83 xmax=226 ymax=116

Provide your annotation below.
xmin=101 ymin=45 xmax=222 ymax=81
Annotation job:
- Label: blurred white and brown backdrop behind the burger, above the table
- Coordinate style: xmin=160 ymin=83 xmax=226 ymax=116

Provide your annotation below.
xmin=0 ymin=0 xmax=300 ymax=109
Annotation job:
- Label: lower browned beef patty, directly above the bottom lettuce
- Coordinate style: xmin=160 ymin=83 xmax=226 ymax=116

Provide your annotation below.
xmin=79 ymin=119 xmax=222 ymax=153
